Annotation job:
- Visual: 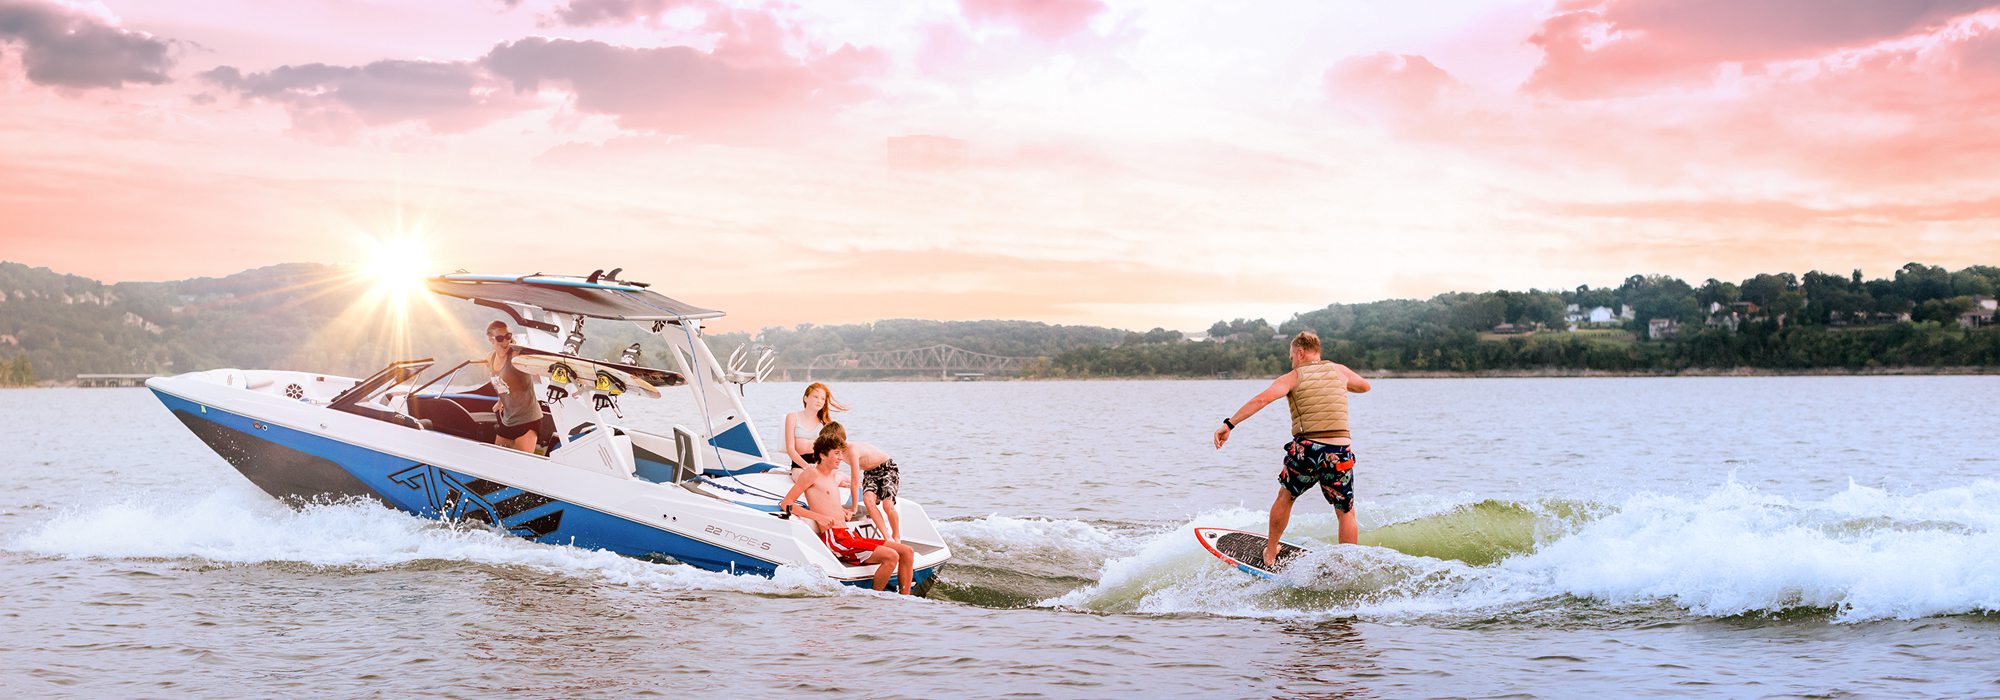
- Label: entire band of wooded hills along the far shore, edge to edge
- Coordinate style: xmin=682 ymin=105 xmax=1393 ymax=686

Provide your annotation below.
xmin=0 ymin=262 xmax=2000 ymax=384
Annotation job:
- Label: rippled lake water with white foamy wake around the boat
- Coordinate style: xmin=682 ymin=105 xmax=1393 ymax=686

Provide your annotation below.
xmin=0 ymin=376 xmax=2000 ymax=698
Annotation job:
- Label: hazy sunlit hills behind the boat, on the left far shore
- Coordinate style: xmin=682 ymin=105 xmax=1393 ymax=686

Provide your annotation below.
xmin=0 ymin=262 xmax=1136 ymax=384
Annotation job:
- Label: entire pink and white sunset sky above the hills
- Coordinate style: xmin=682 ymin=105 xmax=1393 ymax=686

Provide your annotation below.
xmin=0 ymin=0 xmax=2000 ymax=332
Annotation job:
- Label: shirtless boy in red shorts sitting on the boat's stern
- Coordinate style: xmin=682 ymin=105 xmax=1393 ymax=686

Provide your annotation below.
xmin=780 ymin=430 xmax=916 ymax=594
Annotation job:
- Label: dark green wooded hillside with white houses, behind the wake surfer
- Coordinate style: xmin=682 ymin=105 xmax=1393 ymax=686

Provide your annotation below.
xmin=1036 ymin=262 xmax=2000 ymax=376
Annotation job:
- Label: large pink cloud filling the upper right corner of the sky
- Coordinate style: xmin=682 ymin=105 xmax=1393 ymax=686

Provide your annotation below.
xmin=1324 ymin=4 xmax=2000 ymax=204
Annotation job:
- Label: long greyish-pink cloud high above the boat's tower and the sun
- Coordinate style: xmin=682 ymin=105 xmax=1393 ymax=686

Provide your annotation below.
xmin=199 ymin=0 xmax=888 ymax=140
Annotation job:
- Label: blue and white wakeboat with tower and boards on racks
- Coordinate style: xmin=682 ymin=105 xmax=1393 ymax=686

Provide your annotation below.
xmin=146 ymin=270 xmax=952 ymax=590
